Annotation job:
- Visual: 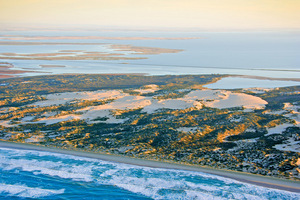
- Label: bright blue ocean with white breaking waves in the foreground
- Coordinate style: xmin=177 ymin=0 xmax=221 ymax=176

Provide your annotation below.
xmin=0 ymin=148 xmax=300 ymax=200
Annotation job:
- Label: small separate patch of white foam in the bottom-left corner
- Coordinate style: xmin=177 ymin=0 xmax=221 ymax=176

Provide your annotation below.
xmin=0 ymin=183 xmax=65 ymax=198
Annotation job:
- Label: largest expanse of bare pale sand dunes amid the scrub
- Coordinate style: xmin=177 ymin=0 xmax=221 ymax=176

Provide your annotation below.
xmin=14 ymin=88 xmax=267 ymax=124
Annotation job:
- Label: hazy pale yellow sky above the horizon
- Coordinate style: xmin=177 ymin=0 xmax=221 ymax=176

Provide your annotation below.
xmin=0 ymin=0 xmax=300 ymax=30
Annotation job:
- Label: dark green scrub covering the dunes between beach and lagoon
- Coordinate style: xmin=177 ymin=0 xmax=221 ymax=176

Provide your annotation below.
xmin=0 ymin=75 xmax=300 ymax=179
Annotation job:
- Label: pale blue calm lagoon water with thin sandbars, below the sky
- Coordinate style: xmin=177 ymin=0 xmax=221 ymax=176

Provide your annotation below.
xmin=0 ymin=32 xmax=300 ymax=81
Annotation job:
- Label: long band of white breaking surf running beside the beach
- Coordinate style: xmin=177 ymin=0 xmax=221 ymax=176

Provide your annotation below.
xmin=0 ymin=148 xmax=300 ymax=200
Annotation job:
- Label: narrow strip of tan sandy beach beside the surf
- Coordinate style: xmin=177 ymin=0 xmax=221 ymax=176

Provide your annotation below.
xmin=0 ymin=141 xmax=300 ymax=193
